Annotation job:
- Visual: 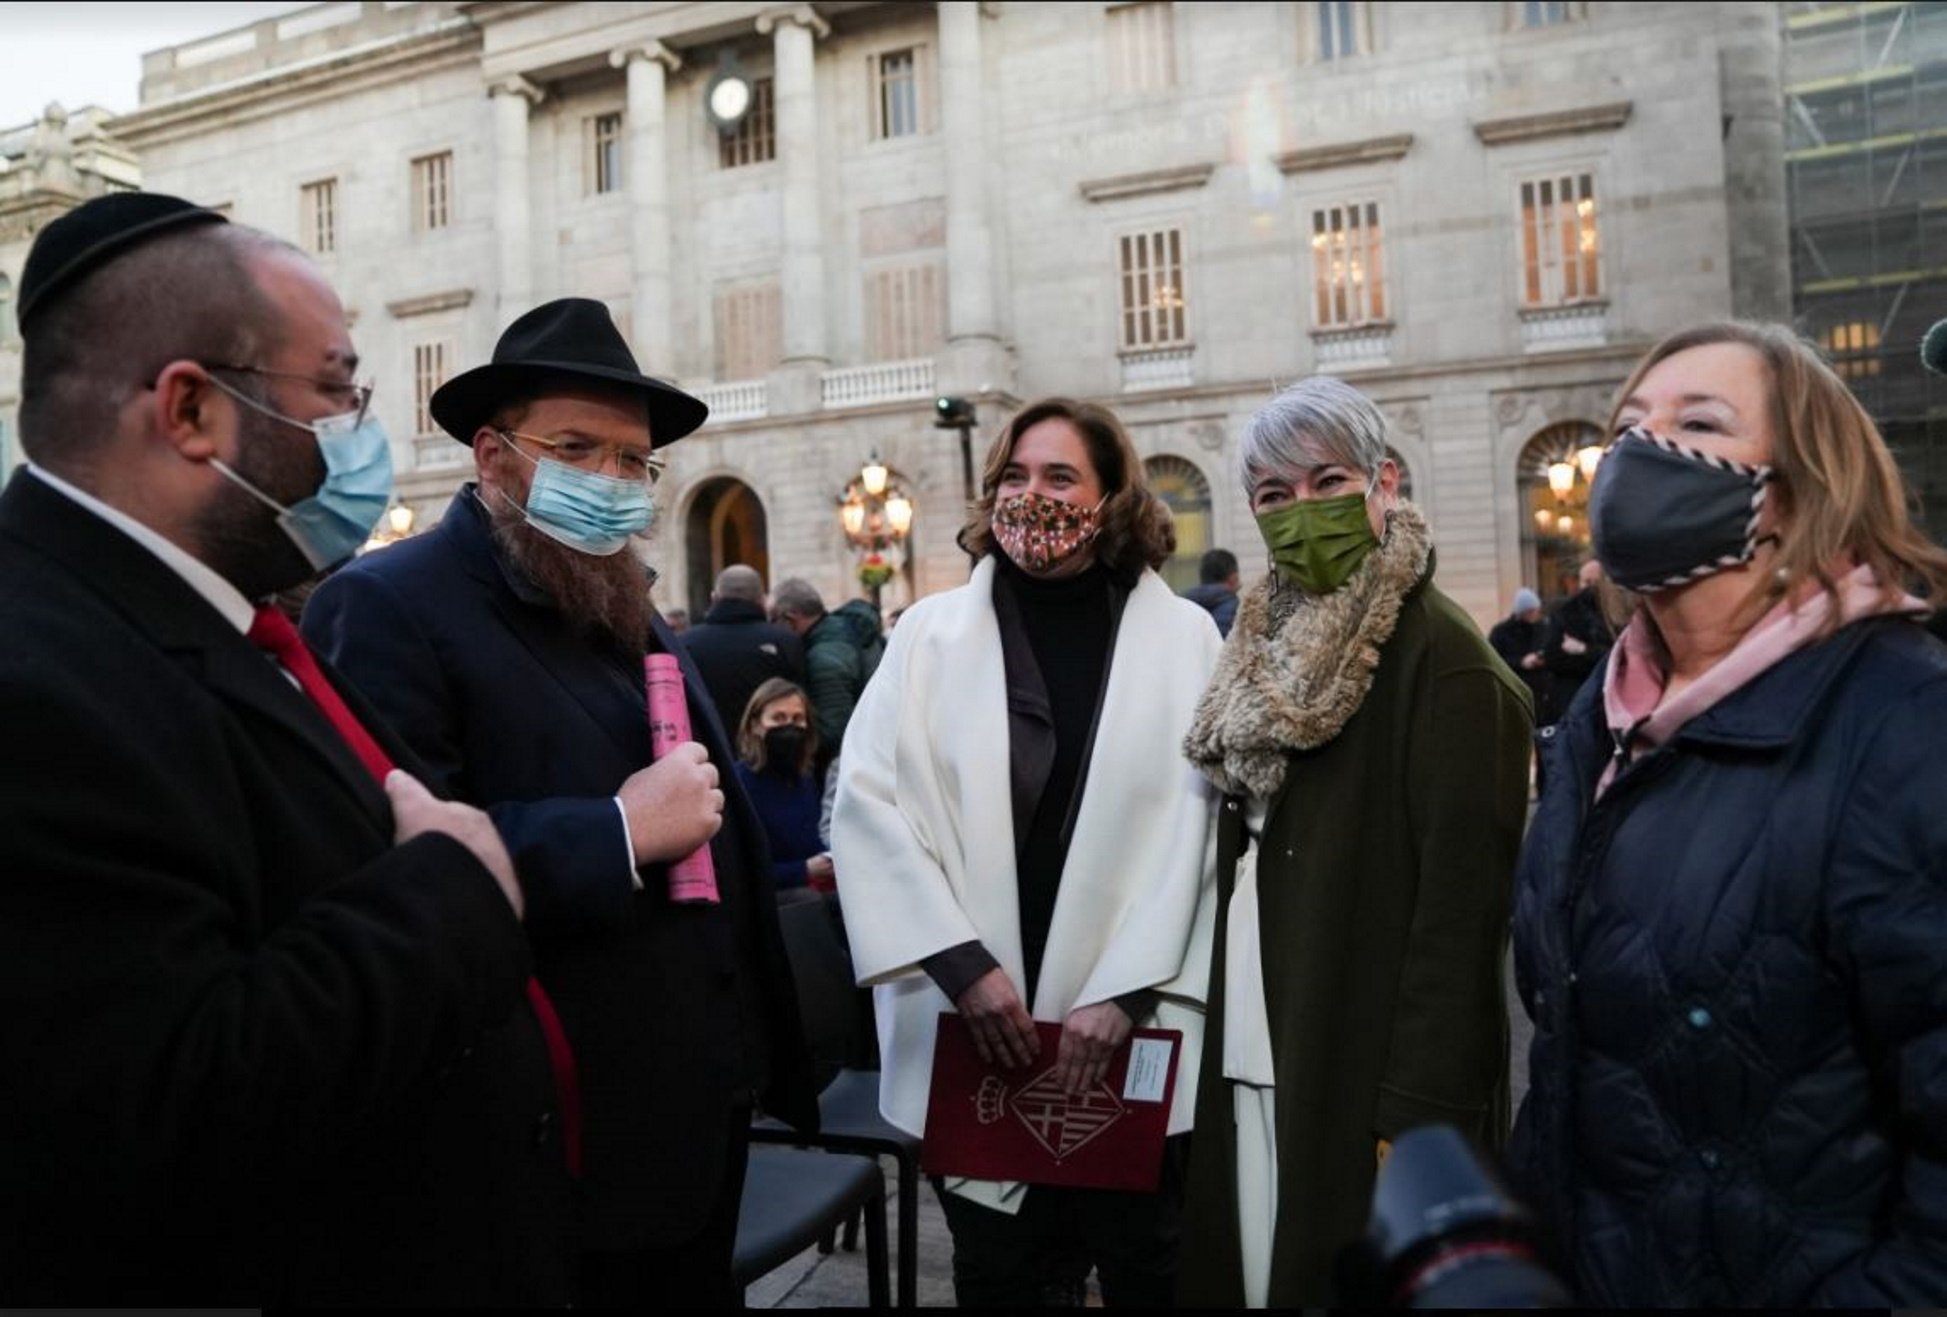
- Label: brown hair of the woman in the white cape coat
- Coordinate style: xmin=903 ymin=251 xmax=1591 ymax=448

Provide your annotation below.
xmin=958 ymin=397 xmax=1176 ymax=586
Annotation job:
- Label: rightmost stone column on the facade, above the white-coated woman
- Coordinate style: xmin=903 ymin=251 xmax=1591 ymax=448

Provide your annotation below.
xmin=937 ymin=0 xmax=1012 ymax=394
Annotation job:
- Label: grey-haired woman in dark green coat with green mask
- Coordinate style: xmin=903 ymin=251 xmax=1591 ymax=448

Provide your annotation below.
xmin=1178 ymin=376 xmax=1532 ymax=1307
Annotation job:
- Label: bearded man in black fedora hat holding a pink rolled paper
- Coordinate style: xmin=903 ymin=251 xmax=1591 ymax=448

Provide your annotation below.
xmin=304 ymin=298 xmax=816 ymax=1307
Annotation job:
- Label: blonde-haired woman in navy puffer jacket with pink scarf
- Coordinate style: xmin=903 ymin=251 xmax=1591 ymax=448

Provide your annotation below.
xmin=1509 ymin=325 xmax=1947 ymax=1307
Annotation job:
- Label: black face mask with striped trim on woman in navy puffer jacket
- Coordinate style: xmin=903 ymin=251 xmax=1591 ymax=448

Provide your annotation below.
xmin=1589 ymin=427 xmax=1772 ymax=594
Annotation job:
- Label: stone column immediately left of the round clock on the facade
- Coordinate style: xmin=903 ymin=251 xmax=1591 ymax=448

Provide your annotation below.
xmin=609 ymin=41 xmax=683 ymax=376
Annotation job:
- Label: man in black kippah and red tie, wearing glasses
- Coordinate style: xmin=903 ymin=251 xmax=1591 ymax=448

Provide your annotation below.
xmin=0 ymin=193 xmax=572 ymax=1307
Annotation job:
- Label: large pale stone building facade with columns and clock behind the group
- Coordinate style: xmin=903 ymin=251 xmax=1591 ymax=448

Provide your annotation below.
xmin=68 ymin=0 xmax=1791 ymax=621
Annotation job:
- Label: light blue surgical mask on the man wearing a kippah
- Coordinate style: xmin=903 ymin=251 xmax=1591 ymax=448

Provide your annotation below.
xmin=210 ymin=376 xmax=391 ymax=571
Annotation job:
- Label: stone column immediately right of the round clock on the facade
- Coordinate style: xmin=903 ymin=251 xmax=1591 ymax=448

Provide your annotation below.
xmin=757 ymin=4 xmax=831 ymax=411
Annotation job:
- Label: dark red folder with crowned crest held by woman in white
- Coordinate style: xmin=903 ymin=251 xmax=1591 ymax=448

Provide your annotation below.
xmin=921 ymin=1013 xmax=1184 ymax=1190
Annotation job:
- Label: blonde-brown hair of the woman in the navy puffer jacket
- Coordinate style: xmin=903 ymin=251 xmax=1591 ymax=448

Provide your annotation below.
xmin=1610 ymin=321 xmax=1947 ymax=627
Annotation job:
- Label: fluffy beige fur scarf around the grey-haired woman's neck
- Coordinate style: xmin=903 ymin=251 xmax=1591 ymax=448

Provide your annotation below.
xmin=1184 ymin=503 xmax=1433 ymax=799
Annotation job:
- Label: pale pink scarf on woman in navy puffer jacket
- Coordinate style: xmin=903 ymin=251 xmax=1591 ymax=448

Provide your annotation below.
xmin=1595 ymin=563 xmax=1929 ymax=799
